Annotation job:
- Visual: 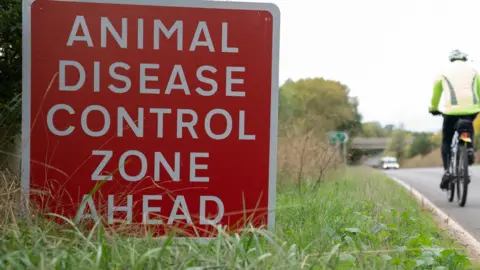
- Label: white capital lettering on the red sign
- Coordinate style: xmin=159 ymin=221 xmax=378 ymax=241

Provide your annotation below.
xmin=47 ymin=15 xmax=256 ymax=224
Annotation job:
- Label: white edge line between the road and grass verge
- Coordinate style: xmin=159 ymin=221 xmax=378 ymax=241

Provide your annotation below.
xmin=387 ymin=175 xmax=480 ymax=262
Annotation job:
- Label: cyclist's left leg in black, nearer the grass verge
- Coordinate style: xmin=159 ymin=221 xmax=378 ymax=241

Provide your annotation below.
xmin=440 ymin=115 xmax=459 ymax=189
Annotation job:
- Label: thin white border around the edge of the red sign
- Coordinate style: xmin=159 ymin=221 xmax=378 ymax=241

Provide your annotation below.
xmin=21 ymin=0 xmax=280 ymax=236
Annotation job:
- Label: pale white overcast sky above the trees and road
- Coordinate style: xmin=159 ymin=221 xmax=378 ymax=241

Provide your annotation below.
xmin=230 ymin=0 xmax=480 ymax=131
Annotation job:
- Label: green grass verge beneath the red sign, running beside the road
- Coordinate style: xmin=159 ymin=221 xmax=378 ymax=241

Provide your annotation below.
xmin=0 ymin=168 xmax=470 ymax=269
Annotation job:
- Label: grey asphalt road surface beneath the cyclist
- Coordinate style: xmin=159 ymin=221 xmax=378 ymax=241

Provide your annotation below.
xmin=386 ymin=166 xmax=480 ymax=241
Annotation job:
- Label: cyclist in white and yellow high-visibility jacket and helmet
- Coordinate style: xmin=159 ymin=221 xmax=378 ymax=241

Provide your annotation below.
xmin=429 ymin=50 xmax=480 ymax=189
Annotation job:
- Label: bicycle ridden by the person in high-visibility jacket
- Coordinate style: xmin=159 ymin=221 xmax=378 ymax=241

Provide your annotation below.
xmin=431 ymin=111 xmax=473 ymax=207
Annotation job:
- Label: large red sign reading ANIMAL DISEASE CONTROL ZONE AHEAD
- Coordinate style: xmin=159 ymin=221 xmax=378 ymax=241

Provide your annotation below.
xmin=22 ymin=0 xmax=279 ymax=237
